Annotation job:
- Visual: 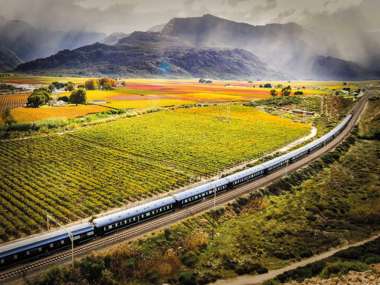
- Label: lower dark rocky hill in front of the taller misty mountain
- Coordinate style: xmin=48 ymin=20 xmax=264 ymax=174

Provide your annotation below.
xmin=17 ymin=41 xmax=282 ymax=79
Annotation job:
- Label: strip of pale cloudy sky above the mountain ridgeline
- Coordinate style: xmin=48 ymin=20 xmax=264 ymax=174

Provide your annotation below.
xmin=0 ymin=0 xmax=372 ymax=34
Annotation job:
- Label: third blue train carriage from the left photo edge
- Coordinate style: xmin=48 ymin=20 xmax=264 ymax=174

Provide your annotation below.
xmin=173 ymin=178 xmax=231 ymax=208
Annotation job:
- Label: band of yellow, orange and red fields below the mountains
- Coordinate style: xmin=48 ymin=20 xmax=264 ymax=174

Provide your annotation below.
xmin=0 ymin=75 xmax=357 ymax=123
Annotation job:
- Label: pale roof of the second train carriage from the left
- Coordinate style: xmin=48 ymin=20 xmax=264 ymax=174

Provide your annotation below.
xmin=93 ymin=197 xmax=176 ymax=227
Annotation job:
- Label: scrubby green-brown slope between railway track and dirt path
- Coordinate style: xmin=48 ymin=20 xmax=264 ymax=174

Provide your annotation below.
xmin=30 ymin=96 xmax=380 ymax=285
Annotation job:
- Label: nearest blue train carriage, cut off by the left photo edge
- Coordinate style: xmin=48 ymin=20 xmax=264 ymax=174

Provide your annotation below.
xmin=0 ymin=223 xmax=95 ymax=268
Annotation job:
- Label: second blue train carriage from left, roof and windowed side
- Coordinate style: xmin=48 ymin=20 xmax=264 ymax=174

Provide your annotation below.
xmin=93 ymin=197 xmax=176 ymax=235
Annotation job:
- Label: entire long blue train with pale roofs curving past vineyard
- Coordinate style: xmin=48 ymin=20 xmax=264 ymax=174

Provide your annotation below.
xmin=0 ymin=114 xmax=352 ymax=269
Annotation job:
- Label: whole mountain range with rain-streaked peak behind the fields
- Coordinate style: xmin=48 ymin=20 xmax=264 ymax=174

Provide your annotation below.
xmin=0 ymin=15 xmax=379 ymax=80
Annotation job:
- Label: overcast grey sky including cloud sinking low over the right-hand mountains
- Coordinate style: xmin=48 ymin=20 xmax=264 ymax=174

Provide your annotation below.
xmin=0 ymin=0 xmax=380 ymax=66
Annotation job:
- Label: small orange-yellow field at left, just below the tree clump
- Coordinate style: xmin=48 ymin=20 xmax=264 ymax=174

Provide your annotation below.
xmin=12 ymin=105 xmax=107 ymax=123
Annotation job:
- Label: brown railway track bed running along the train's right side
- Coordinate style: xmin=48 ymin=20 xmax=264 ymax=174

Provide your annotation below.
xmin=0 ymin=92 xmax=368 ymax=284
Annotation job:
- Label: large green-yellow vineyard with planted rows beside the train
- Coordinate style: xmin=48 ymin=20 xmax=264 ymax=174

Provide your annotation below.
xmin=0 ymin=105 xmax=310 ymax=241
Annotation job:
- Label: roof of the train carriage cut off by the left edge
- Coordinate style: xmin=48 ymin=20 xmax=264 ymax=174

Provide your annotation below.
xmin=0 ymin=222 xmax=94 ymax=258
